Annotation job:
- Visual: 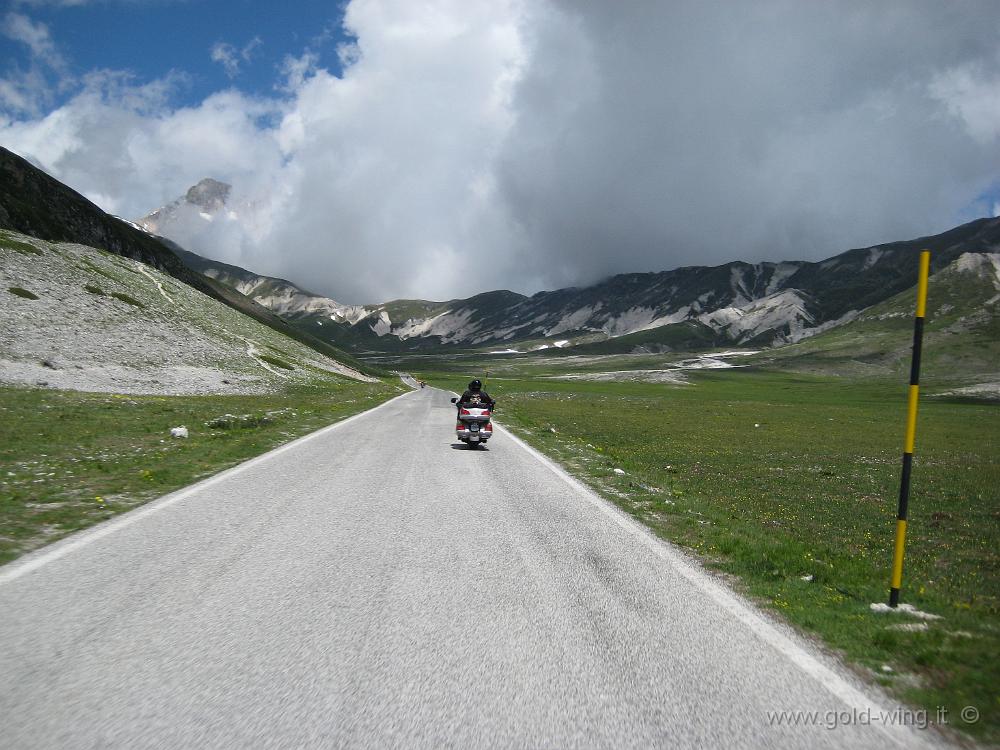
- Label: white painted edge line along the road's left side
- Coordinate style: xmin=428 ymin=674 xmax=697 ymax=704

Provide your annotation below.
xmin=0 ymin=391 xmax=416 ymax=586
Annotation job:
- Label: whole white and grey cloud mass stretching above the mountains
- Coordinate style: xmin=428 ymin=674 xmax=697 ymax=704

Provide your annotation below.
xmin=0 ymin=0 xmax=1000 ymax=302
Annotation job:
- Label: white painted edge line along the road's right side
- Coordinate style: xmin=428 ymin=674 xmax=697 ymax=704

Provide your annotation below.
xmin=493 ymin=420 xmax=938 ymax=748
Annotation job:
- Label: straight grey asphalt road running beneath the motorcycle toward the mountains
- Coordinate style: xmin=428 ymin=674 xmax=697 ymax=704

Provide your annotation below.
xmin=0 ymin=388 xmax=930 ymax=748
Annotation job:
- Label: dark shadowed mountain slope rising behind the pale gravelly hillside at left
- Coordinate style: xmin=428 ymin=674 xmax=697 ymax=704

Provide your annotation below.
xmin=0 ymin=148 xmax=369 ymax=372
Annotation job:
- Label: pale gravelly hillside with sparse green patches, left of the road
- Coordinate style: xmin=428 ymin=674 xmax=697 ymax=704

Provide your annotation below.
xmin=0 ymin=231 xmax=370 ymax=394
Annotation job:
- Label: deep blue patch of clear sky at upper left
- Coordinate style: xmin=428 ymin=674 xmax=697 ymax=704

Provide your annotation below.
xmin=3 ymin=0 xmax=351 ymax=106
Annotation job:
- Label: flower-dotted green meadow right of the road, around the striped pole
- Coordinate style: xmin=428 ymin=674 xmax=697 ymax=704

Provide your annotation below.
xmin=415 ymin=365 xmax=1000 ymax=741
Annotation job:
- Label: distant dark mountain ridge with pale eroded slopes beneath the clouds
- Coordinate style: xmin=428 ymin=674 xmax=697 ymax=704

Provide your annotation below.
xmin=150 ymin=175 xmax=1000 ymax=352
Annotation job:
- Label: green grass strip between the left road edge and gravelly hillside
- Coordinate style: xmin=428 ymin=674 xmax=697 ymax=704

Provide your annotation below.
xmin=0 ymin=380 xmax=399 ymax=563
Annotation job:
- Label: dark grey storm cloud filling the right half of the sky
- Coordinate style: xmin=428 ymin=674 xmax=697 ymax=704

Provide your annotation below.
xmin=490 ymin=2 xmax=1000 ymax=292
